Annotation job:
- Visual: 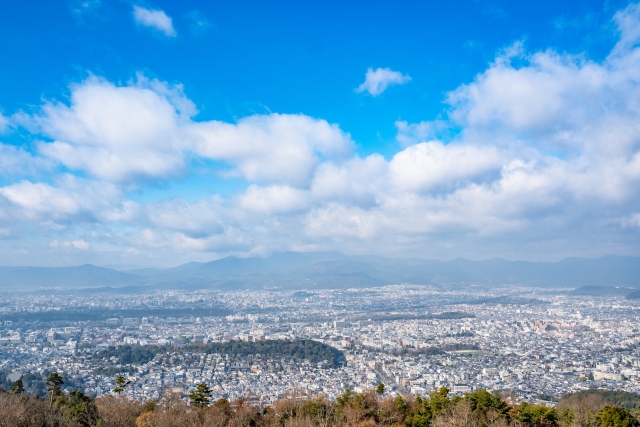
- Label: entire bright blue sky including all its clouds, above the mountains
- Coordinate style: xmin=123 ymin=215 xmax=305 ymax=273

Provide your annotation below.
xmin=0 ymin=0 xmax=640 ymax=265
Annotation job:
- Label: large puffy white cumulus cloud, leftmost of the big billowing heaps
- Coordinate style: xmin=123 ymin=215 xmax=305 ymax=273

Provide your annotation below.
xmin=34 ymin=77 xmax=195 ymax=180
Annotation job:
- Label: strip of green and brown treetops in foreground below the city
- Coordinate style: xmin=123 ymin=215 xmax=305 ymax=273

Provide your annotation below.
xmin=0 ymin=381 xmax=640 ymax=427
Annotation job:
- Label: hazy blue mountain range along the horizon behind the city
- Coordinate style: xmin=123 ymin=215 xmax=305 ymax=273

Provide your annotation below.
xmin=0 ymin=252 xmax=640 ymax=294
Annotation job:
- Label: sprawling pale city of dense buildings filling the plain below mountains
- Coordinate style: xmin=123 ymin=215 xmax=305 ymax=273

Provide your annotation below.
xmin=0 ymin=285 xmax=640 ymax=405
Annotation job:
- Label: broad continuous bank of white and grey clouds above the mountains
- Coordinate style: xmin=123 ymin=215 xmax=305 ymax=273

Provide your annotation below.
xmin=0 ymin=5 xmax=640 ymax=265
